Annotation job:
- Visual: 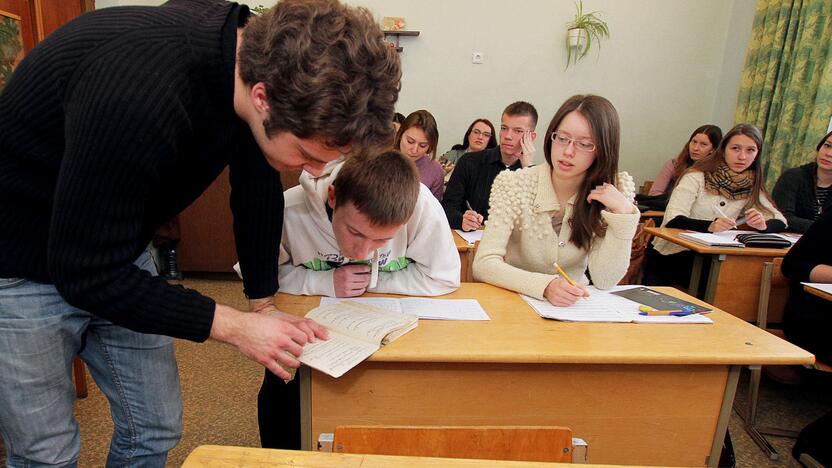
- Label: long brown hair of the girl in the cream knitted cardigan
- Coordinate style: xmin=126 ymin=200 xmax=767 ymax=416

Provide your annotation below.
xmin=543 ymin=94 xmax=621 ymax=250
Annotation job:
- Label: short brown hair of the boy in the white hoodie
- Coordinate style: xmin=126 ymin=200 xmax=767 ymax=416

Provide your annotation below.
xmin=333 ymin=150 xmax=420 ymax=226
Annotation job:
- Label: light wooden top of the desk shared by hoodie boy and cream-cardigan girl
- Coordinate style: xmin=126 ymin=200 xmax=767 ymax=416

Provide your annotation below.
xmin=277 ymin=283 xmax=814 ymax=365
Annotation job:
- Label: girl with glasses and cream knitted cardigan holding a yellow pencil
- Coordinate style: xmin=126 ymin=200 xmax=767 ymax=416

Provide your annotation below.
xmin=474 ymin=95 xmax=639 ymax=306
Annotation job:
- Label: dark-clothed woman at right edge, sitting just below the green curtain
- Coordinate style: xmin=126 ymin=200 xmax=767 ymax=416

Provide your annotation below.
xmin=771 ymin=132 xmax=832 ymax=232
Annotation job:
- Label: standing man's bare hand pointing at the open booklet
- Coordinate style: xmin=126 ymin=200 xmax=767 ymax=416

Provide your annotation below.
xmin=211 ymin=304 xmax=309 ymax=380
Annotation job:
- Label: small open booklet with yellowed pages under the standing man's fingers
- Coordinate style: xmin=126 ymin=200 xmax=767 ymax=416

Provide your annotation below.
xmin=299 ymin=301 xmax=419 ymax=378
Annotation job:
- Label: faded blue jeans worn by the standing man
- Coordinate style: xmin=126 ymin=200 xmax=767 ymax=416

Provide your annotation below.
xmin=0 ymin=251 xmax=182 ymax=467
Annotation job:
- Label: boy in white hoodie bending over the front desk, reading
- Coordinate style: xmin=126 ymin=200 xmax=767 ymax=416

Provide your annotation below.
xmin=258 ymin=151 xmax=460 ymax=450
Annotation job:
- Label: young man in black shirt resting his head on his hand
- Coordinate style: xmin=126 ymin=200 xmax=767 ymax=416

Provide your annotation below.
xmin=442 ymin=101 xmax=537 ymax=231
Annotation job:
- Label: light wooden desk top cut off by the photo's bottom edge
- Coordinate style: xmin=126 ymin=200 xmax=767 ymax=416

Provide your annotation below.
xmin=182 ymin=445 xmax=621 ymax=468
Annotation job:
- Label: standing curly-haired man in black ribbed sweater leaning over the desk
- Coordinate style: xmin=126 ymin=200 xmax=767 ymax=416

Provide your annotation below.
xmin=0 ymin=0 xmax=400 ymax=466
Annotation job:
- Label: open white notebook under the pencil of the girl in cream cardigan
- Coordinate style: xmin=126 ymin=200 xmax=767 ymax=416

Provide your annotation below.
xmin=521 ymin=286 xmax=713 ymax=323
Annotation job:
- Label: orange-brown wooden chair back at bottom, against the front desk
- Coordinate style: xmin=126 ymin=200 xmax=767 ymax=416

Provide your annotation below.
xmin=332 ymin=426 xmax=572 ymax=463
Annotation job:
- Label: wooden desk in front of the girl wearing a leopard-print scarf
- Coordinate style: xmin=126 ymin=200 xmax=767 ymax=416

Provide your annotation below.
xmin=644 ymin=228 xmax=789 ymax=322
